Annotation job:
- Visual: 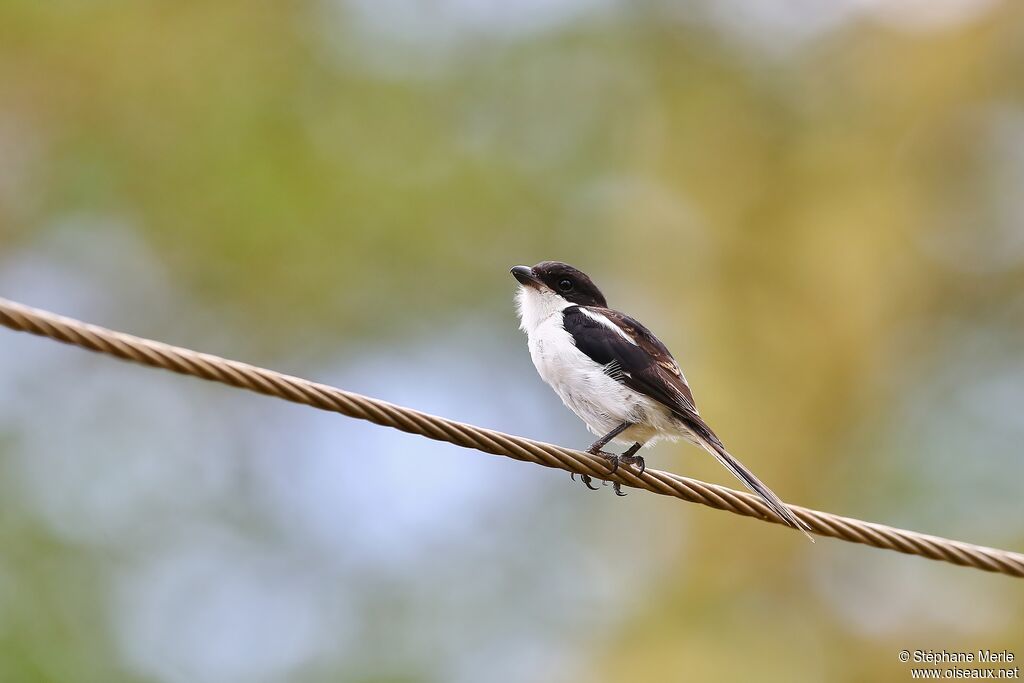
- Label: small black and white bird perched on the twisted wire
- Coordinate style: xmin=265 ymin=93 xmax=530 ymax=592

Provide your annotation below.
xmin=511 ymin=261 xmax=813 ymax=540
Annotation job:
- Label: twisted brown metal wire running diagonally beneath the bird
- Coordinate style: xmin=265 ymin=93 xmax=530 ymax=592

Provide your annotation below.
xmin=0 ymin=298 xmax=1024 ymax=578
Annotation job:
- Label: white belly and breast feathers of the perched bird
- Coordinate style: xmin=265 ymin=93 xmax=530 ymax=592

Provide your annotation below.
xmin=528 ymin=313 xmax=678 ymax=442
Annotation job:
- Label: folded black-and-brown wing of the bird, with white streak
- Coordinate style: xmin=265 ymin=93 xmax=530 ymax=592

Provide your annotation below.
xmin=562 ymin=306 xmax=704 ymax=421
